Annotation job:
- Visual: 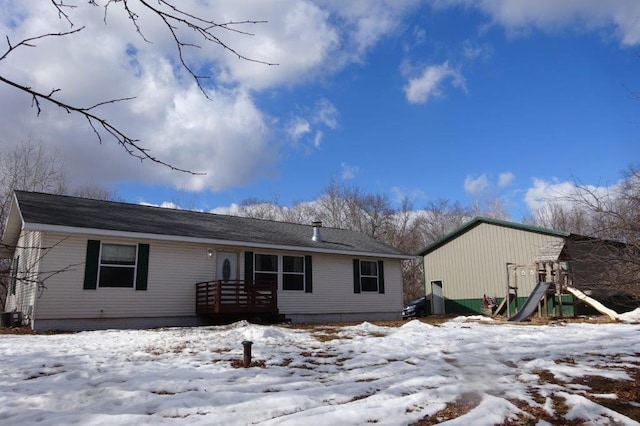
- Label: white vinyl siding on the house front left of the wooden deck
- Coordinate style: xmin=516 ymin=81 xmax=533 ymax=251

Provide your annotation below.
xmin=37 ymin=234 xmax=215 ymax=319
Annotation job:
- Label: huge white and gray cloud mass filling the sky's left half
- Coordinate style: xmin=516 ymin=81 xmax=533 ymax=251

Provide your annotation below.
xmin=5 ymin=0 xmax=418 ymax=191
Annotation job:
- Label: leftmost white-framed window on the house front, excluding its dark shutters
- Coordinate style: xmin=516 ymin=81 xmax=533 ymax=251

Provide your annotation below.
xmin=98 ymin=243 xmax=138 ymax=288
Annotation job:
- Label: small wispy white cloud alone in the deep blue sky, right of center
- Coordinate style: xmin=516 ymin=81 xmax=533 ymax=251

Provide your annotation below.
xmin=404 ymin=61 xmax=466 ymax=104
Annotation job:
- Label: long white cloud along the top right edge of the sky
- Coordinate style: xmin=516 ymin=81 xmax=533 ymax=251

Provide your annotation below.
xmin=432 ymin=0 xmax=640 ymax=46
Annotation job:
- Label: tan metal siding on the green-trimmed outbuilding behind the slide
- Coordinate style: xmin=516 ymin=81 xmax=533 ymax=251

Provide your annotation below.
xmin=424 ymin=223 xmax=563 ymax=299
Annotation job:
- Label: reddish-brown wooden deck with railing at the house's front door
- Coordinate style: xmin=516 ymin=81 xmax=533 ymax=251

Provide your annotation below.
xmin=196 ymin=281 xmax=278 ymax=319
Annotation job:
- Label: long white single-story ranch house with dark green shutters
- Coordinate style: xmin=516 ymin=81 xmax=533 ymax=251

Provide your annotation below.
xmin=0 ymin=191 xmax=410 ymax=330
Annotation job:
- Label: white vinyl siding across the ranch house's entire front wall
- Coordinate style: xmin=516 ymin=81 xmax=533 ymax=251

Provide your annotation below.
xmin=28 ymin=233 xmax=402 ymax=327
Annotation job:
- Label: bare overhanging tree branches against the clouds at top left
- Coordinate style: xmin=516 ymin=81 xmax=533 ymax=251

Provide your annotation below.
xmin=0 ymin=0 xmax=276 ymax=174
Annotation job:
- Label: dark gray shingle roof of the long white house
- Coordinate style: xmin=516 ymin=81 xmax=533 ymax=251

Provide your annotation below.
xmin=16 ymin=191 xmax=410 ymax=257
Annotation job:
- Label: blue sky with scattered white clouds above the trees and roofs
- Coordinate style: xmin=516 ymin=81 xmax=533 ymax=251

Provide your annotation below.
xmin=0 ymin=0 xmax=640 ymax=220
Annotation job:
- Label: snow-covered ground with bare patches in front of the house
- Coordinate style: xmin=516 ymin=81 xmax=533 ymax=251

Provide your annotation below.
xmin=0 ymin=310 xmax=640 ymax=425
